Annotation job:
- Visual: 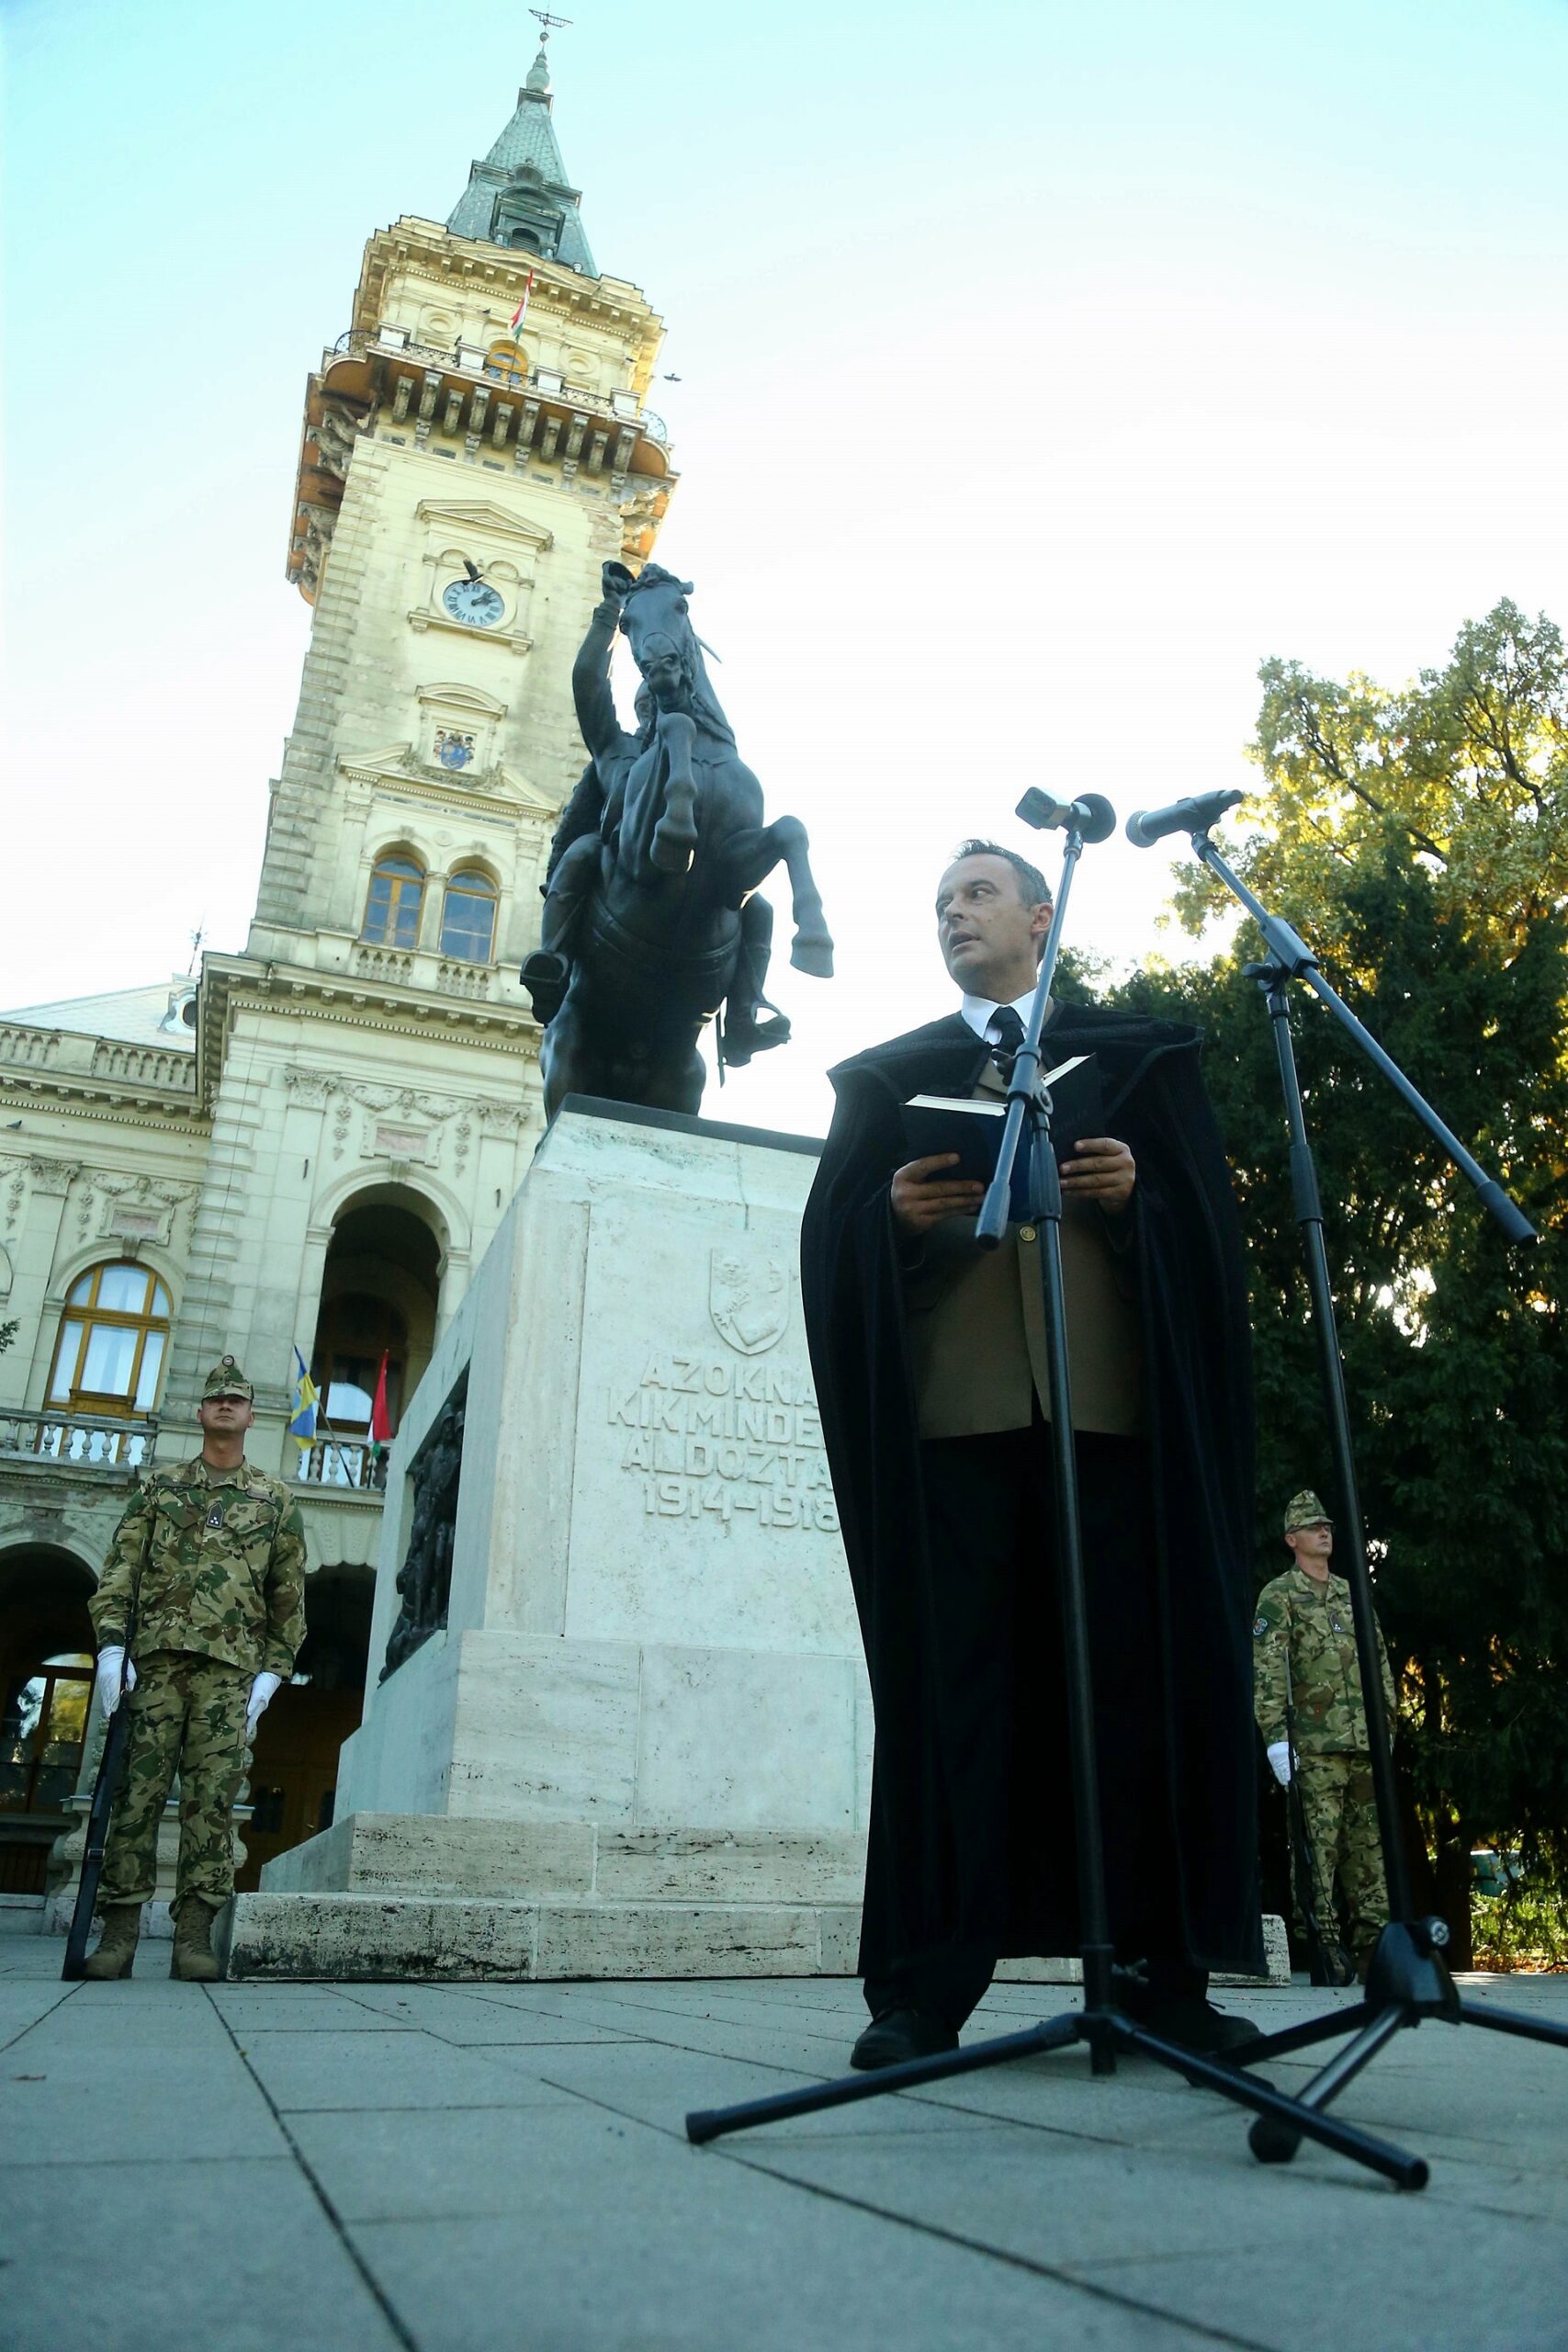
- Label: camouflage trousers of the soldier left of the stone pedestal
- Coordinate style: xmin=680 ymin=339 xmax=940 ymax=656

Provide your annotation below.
xmin=98 ymin=1649 xmax=254 ymax=1905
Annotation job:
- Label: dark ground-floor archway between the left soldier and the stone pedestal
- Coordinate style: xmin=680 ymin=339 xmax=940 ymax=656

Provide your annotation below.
xmin=235 ymin=1564 xmax=376 ymax=1891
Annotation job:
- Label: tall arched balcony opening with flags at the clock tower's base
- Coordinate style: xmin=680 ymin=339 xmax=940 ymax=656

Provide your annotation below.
xmin=306 ymin=1185 xmax=442 ymax=1487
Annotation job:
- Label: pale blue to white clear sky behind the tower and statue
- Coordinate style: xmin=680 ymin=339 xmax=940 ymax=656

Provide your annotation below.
xmin=0 ymin=0 xmax=1568 ymax=1129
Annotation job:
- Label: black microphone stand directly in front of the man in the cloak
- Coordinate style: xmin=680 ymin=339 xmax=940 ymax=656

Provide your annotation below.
xmin=686 ymin=793 xmax=1427 ymax=2188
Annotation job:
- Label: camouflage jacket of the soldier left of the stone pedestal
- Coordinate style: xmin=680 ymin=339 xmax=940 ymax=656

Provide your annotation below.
xmin=87 ymin=1453 xmax=306 ymax=1677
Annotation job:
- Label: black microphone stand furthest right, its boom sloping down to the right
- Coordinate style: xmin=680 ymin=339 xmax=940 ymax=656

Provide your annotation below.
xmin=1170 ymin=816 xmax=1568 ymax=2185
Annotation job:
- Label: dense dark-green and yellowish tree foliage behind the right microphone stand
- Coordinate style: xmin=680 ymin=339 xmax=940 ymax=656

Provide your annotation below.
xmin=1119 ymin=605 xmax=1568 ymax=1957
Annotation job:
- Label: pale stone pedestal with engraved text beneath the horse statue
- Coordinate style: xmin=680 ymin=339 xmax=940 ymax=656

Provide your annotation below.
xmin=231 ymin=1103 xmax=872 ymax=1975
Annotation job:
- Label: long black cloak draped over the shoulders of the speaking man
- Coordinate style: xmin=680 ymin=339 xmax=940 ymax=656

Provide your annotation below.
xmin=802 ymin=1004 xmax=1262 ymax=1975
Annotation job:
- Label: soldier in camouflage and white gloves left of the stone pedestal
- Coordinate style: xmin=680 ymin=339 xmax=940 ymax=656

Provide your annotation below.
xmin=87 ymin=1355 xmax=306 ymax=1981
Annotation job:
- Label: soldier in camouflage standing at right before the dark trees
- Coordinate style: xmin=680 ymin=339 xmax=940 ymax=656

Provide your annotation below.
xmin=1253 ymin=1488 xmax=1394 ymax=1975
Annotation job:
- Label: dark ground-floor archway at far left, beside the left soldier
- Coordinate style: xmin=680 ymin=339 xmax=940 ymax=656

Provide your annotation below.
xmin=0 ymin=1545 xmax=94 ymax=1895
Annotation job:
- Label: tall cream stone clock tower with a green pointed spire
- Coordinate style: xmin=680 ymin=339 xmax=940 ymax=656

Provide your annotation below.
xmin=164 ymin=50 xmax=674 ymax=1505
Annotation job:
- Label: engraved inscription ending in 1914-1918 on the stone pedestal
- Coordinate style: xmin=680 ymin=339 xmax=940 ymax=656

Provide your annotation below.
xmin=609 ymin=1355 xmax=840 ymax=1536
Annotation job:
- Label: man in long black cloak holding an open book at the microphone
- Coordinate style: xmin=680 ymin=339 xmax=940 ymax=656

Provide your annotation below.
xmin=802 ymin=842 xmax=1262 ymax=2067
